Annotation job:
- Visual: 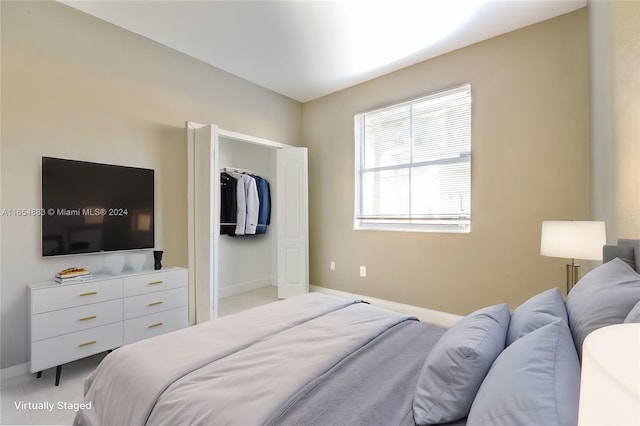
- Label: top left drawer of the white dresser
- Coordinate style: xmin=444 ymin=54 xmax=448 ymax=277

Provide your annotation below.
xmin=31 ymin=278 xmax=122 ymax=315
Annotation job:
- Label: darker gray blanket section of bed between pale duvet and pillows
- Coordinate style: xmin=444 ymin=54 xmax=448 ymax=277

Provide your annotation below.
xmin=267 ymin=321 xmax=445 ymax=426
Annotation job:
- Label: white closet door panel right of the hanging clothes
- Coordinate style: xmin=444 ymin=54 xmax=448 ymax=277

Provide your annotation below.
xmin=276 ymin=148 xmax=309 ymax=299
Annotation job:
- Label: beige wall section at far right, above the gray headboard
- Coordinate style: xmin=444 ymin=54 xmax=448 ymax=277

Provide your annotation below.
xmin=589 ymin=1 xmax=640 ymax=243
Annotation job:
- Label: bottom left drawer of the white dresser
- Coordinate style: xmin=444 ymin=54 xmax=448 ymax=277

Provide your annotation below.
xmin=31 ymin=322 xmax=122 ymax=373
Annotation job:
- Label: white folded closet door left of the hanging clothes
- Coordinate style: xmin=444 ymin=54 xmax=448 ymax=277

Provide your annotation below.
xmin=188 ymin=125 xmax=220 ymax=323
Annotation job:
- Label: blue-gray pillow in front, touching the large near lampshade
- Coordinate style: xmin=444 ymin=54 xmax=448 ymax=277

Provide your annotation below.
xmin=467 ymin=319 xmax=580 ymax=426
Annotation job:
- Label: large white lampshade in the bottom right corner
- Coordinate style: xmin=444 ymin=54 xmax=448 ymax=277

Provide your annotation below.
xmin=578 ymin=323 xmax=640 ymax=426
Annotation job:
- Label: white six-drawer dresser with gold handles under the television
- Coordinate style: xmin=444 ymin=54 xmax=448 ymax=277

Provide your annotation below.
xmin=28 ymin=268 xmax=189 ymax=385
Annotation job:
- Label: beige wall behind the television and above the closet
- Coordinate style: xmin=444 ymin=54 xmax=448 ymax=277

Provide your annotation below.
xmin=0 ymin=1 xmax=302 ymax=368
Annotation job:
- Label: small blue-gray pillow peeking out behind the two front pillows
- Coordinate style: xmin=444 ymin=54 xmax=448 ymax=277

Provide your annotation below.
xmin=507 ymin=287 xmax=569 ymax=346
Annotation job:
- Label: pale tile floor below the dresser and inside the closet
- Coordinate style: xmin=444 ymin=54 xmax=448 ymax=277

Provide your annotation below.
xmin=0 ymin=286 xmax=278 ymax=425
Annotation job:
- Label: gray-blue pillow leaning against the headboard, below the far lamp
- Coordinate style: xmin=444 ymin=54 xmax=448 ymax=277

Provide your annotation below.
xmin=565 ymin=259 xmax=640 ymax=357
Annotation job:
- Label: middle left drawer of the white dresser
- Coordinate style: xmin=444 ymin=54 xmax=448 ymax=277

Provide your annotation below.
xmin=31 ymin=299 xmax=123 ymax=342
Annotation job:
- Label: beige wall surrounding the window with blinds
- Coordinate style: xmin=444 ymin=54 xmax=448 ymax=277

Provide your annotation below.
xmin=303 ymin=9 xmax=591 ymax=314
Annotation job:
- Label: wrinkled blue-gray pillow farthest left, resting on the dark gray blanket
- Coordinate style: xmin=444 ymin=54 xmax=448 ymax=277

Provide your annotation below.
xmin=413 ymin=303 xmax=510 ymax=425
